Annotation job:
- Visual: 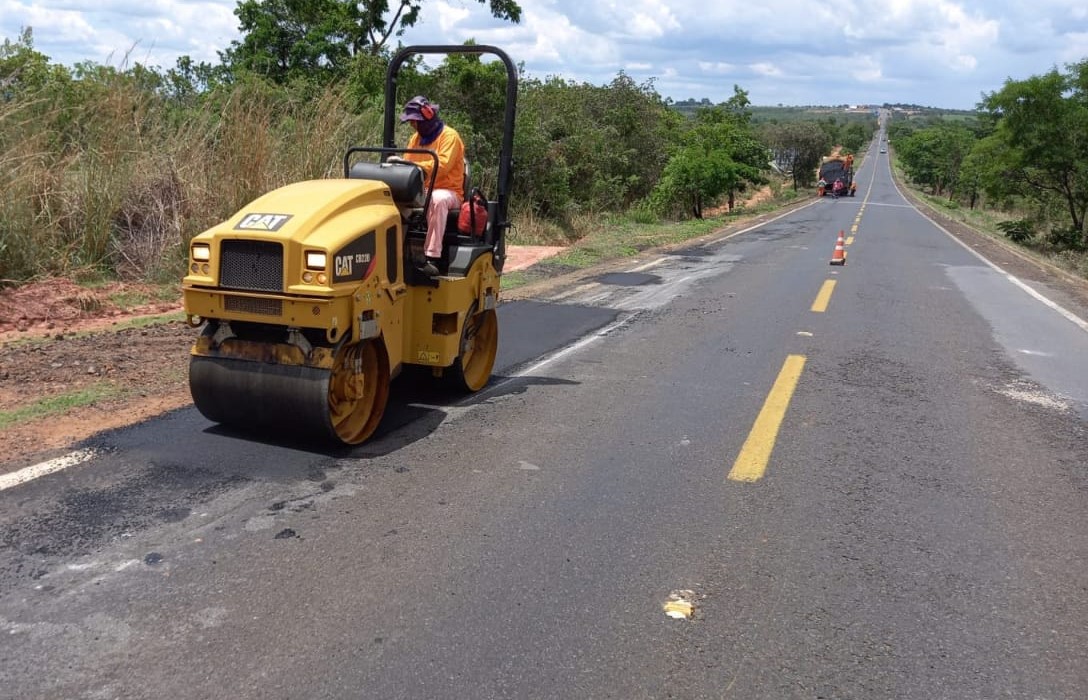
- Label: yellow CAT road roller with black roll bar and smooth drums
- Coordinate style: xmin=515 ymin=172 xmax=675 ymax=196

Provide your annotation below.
xmin=182 ymin=46 xmax=517 ymax=444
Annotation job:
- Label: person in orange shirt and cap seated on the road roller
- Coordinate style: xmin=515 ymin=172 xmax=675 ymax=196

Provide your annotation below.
xmin=400 ymin=95 xmax=465 ymax=277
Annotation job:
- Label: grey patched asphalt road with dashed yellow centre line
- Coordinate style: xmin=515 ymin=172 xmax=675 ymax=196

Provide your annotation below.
xmin=0 ymin=138 xmax=1088 ymax=700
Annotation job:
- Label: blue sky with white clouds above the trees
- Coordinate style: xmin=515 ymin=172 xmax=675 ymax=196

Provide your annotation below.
xmin=0 ymin=0 xmax=1088 ymax=109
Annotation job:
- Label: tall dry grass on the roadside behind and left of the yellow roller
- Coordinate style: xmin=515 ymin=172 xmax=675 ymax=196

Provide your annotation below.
xmin=0 ymin=74 xmax=381 ymax=283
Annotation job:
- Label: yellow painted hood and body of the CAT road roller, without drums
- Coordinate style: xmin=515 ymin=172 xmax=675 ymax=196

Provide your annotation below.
xmin=183 ymin=179 xmax=499 ymax=371
